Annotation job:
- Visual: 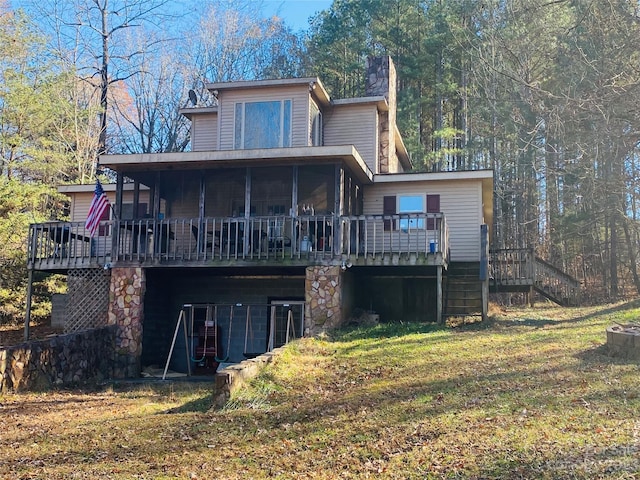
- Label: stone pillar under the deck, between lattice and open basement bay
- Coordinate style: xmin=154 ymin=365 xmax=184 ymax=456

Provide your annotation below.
xmin=108 ymin=267 xmax=145 ymax=378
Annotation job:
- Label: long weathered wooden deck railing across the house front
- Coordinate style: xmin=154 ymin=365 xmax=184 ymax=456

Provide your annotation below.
xmin=29 ymin=213 xmax=449 ymax=269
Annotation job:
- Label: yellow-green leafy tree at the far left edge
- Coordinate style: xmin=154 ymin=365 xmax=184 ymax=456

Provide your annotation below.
xmin=0 ymin=5 xmax=81 ymax=323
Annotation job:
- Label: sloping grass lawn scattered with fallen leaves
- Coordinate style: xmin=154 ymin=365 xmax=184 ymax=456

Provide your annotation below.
xmin=0 ymin=302 xmax=640 ymax=479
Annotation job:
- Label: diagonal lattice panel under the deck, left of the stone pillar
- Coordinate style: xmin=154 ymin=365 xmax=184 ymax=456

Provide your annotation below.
xmin=64 ymin=268 xmax=111 ymax=333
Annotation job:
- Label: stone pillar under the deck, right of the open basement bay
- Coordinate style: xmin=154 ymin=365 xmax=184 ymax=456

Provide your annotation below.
xmin=305 ymin=266 xmax=343 ymax=335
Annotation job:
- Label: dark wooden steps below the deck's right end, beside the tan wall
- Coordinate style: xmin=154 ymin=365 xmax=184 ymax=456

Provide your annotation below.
xmin=443 ymin=262 xmax=482 ymax=318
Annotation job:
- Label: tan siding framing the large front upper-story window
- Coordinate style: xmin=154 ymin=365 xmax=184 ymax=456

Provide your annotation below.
xmin=218 ymin=87 xmax=309 ymax=150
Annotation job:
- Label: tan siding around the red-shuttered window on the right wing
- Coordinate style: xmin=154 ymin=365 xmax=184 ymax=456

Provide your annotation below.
xmin=364 ymin=180 xmax=482 ymax=262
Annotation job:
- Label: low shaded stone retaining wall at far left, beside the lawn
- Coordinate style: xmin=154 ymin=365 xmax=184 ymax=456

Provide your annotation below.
xmin=0 ymin=327 xmax=115 ymax=392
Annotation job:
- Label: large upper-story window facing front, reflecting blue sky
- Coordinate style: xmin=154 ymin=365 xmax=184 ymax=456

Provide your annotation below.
xmin=234 ymin=100 xmax=291 ymax=149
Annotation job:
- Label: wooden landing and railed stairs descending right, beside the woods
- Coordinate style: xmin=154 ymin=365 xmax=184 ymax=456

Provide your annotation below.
xmin=489 ymin=248 xmax=580 ymax=307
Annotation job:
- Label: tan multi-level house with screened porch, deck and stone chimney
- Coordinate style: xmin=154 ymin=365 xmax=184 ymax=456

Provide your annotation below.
xmin=29 ymin=57 xmax=493 ymax=376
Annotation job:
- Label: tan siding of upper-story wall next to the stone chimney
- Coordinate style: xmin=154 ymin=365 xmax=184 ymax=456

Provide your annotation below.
xmin=324 ymin=105 xmax=378 ymax=173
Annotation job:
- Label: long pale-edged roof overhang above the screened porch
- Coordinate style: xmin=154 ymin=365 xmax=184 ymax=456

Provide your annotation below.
xmin=100 ymin=145 xmax=373 ymax=184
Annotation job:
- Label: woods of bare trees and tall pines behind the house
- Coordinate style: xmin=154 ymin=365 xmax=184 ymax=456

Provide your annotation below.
xmin=0 ymin=0 xmax=640 ymax=322
